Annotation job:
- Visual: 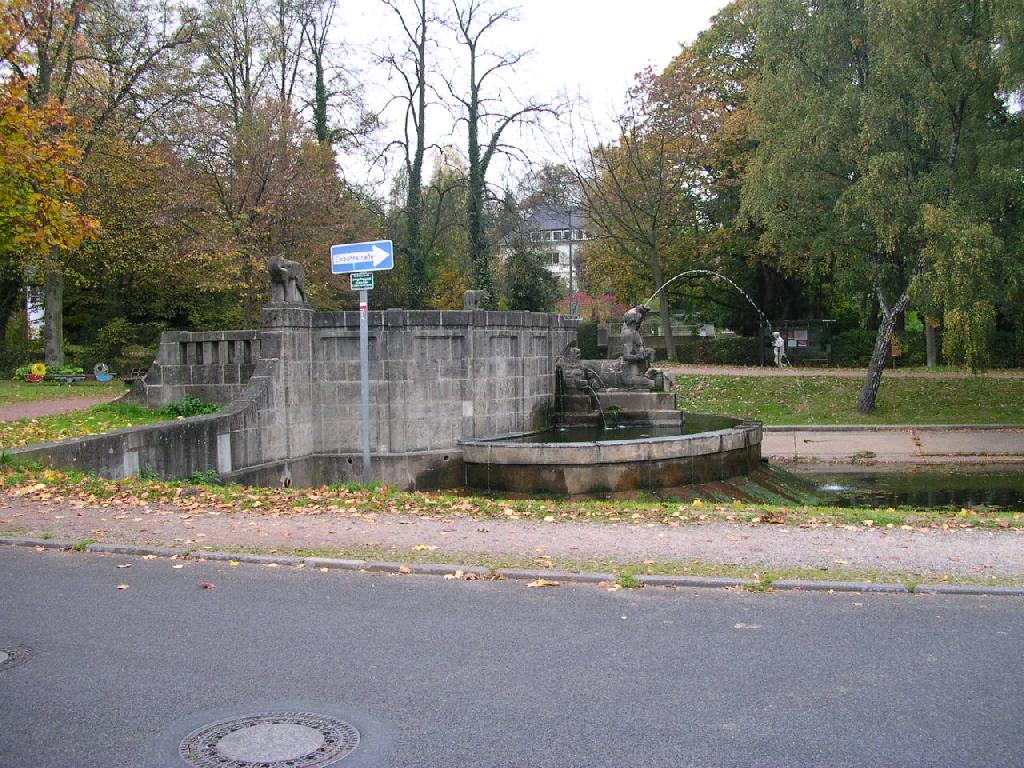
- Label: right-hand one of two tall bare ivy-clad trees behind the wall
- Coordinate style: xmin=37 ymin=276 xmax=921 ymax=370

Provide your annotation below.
xmin=446 ymin=0 xmax=555 ymax=307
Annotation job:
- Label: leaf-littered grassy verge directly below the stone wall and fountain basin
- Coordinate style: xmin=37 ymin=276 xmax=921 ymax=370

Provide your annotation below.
xmin=0 ymin=467 xmax=1024 ymax=529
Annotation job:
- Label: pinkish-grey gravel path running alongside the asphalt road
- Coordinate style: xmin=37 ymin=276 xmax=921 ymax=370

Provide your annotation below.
xmin=0 ymin=492 xmax=1024 ymax=580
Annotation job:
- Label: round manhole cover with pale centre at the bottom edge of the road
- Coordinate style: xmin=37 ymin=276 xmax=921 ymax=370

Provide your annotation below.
xmin=178 ymin=712 xmax=359 ymax=768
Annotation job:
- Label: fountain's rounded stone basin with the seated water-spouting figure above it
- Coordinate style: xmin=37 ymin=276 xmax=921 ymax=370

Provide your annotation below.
xmin=459 ymin=296 xmax=762 ymax=494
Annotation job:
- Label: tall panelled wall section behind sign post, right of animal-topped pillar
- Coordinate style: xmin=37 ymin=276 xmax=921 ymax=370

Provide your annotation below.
xmin=311 ymin=310 xmax=575 ymax=454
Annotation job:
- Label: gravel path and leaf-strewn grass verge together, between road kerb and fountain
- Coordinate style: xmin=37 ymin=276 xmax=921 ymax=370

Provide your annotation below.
xmin=0 ymin=468 xmax=1024 ymax=586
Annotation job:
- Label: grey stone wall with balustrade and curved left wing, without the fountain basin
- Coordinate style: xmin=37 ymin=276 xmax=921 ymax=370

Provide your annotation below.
xmin=15 ymin=304 xmax=577 ymax=487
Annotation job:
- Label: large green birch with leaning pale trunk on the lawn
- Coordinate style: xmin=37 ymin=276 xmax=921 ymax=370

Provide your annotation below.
xmin=742 ymin=0 xmax=1021 ymax=412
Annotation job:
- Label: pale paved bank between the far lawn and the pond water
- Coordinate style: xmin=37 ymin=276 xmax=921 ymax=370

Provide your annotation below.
xmin=762 ymin=425 xmax=1024 ymax=465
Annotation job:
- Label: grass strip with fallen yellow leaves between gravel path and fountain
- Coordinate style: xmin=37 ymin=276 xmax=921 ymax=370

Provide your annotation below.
xmin=0 ymin=467 xmax=1024 ymax=536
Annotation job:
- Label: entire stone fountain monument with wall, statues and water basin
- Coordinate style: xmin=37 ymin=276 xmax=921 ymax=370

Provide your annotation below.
xmin=12 ymin=258 xmax=761 ymax=494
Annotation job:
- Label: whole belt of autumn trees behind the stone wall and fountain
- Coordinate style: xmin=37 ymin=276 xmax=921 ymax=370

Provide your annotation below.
xmin=0 ymin=0 xmax=1024 ymax=403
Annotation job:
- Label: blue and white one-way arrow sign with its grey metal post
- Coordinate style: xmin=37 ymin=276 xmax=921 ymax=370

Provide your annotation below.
xmin=331 ymin=240 xmax=394 ymax=484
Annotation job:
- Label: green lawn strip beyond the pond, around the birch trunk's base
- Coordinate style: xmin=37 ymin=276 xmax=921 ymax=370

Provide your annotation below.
xmin=676 ymin=374 xmax=1024 ymax=424
